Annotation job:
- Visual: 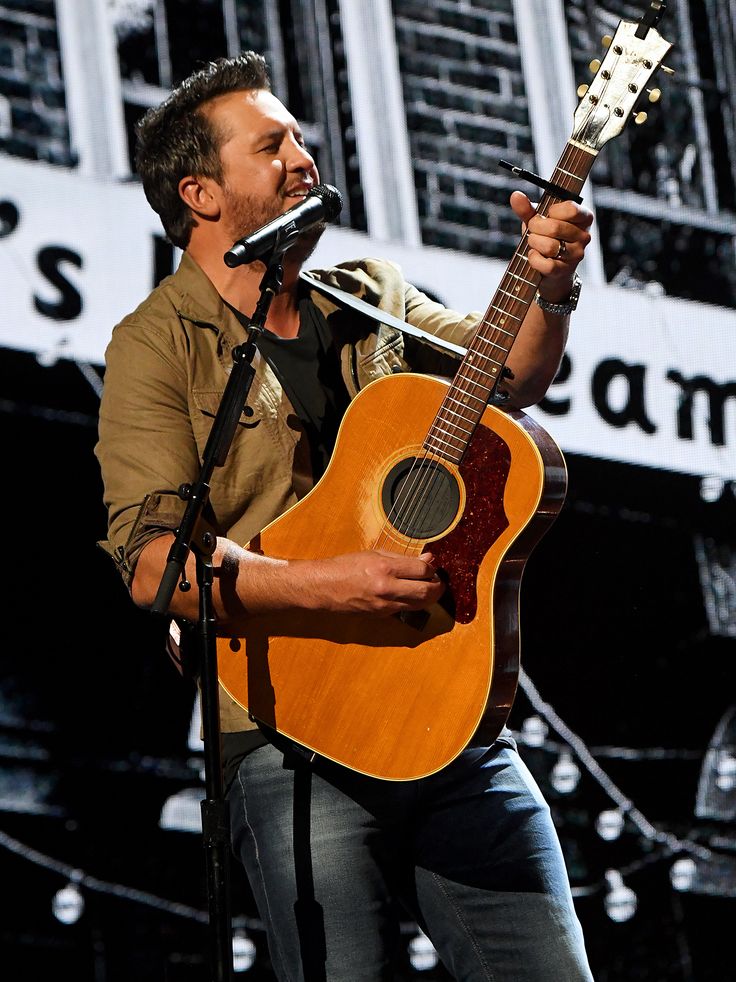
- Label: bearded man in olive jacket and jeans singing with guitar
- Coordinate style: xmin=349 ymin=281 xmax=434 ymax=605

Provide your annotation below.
xmin=97 ymin=52 xmax=592 ymax=982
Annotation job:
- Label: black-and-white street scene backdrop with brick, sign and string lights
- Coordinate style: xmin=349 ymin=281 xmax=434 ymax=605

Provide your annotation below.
xmin=0 ymin=0 xmax=736 ymax=982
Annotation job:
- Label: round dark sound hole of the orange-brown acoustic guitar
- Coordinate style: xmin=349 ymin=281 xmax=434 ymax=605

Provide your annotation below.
xmin=381 ymin=457 xmax=460 ymax=539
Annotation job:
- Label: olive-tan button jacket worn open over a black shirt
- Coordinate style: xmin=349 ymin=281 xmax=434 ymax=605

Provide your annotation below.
xmin=95 ymin=253 xmax=479 ymax=730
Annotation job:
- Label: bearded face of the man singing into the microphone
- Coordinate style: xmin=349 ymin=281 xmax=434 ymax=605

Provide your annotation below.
xmin=209 ymin=89 xmax=324 ymax=260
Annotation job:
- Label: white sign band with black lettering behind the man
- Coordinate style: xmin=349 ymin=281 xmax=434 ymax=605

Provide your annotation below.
xmin=0 ymin=157 xmax=736 ymax=481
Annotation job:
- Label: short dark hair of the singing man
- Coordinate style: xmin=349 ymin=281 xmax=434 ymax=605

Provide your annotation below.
xmin=135 ymin=51 xmax=271 ymax=249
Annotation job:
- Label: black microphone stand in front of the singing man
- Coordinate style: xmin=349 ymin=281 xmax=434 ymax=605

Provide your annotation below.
xmin=151 ymin=233 xmax=299 ymax=982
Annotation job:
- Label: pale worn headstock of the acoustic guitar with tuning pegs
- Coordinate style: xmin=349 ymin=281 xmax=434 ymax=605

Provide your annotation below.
xmin=571 ymin=10 xmax=672 ymax=153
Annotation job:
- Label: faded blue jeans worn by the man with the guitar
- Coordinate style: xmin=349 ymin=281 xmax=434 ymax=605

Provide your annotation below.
xmin=228 ymin=737 xmax=592 ymax=982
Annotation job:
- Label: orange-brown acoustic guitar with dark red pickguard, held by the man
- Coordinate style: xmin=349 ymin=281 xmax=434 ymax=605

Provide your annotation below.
xmin=218 ymin=3 xmax=671 ymax=780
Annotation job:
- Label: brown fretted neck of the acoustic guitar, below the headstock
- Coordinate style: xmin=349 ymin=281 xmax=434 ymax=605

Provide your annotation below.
xmin=424 ymin=141 xmax=597 ymax=464
